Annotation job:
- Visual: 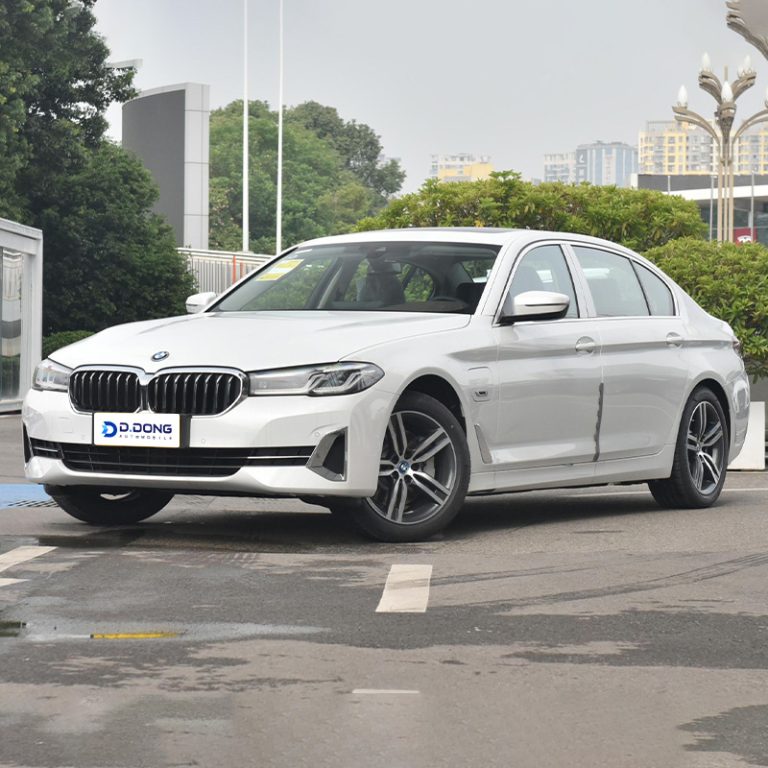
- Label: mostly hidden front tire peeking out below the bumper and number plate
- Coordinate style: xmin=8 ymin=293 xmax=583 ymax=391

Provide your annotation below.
xmin=45 ymin=485 xmax=174 ymax=526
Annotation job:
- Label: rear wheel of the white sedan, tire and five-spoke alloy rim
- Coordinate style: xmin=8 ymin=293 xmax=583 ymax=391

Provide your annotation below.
xmin=648 ymin=387 xmax=729 ymax=509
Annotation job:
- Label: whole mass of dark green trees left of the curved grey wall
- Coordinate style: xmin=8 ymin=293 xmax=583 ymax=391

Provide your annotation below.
xmin=0 ymin=0 xmax=190 ymax=333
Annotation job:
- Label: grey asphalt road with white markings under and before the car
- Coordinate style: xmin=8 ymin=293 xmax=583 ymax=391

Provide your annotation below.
xmin=0 ymin=417 xmax=768 ymax=768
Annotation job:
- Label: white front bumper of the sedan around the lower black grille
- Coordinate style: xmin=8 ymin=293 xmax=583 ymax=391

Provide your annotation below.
xmin=22 ymin=387 xmax=393 ymax=497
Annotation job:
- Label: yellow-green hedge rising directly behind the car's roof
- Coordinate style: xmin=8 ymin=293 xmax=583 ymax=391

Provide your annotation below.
xmin=357 ymin=171 xmax=705 ymax=251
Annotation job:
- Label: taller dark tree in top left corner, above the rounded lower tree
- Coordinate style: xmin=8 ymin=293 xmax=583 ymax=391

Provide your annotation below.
xmin=0 ymin=0 xmax=135 ymax=218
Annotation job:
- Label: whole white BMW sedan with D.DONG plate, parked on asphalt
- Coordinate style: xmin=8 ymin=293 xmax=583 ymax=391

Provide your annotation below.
xmin=23 ymin=229 xmax=749 ymax=541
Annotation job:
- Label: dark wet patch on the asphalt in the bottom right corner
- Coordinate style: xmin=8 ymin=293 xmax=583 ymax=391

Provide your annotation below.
xmin=680 ymin=705 xmax=768 ymax=765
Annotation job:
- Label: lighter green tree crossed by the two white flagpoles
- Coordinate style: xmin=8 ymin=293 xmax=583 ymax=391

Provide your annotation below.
xmin=210 ymin=101 xmax=376 ymax=253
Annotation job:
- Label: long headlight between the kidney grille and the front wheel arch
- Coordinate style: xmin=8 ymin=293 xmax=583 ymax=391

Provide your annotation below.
xmin=248 ymin=363 xmax=384 ymax=396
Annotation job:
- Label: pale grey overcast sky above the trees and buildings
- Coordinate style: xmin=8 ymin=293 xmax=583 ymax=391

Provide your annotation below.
xmin=95 ymin=0 xmax=768 ymax=191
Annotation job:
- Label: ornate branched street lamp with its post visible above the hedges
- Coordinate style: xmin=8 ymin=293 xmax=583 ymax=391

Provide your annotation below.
xmin=672 ymin=53 xmax=768 ymax=242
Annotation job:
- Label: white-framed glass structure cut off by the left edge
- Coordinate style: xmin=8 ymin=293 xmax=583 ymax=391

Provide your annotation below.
xmin=0 ymin=219 xmax=43 ymax=412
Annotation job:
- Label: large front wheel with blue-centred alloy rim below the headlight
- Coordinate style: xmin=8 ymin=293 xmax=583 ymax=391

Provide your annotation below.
xmin=329 ymin=392 xmax=470 ymax=542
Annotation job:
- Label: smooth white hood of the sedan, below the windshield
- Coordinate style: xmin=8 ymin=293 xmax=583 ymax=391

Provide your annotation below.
xmin=51 ymin=311 xmax=470 ymax=372
